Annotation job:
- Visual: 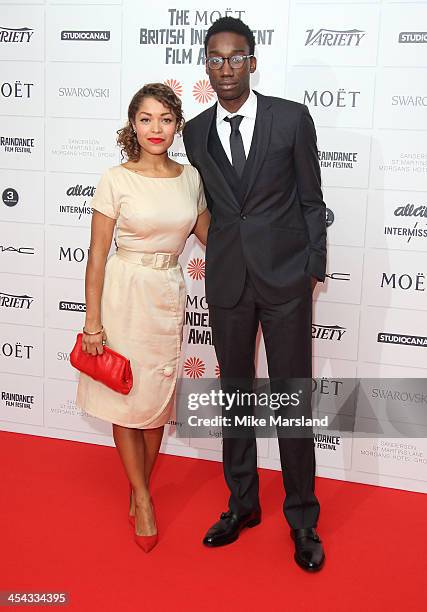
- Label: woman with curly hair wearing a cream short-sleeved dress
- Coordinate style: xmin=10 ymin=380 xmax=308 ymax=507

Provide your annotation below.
xmin=77 ymin=83 xmax=210 ymax=552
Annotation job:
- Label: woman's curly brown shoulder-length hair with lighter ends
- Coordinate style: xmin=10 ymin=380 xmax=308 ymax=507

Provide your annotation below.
xmin=117 ymin=83 xmax=184 ymax=161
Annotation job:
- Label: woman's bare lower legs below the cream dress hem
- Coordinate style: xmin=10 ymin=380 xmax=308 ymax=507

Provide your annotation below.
xmin=113 ymin=424 xmax=157 ymax=535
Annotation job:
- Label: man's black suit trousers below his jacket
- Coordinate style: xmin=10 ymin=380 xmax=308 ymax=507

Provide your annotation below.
xmin=209 ymin=277 xmax=320 ymax=529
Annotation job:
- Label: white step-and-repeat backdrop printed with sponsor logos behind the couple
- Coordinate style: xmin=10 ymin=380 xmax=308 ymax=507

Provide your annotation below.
xmin=0 ymin=0 xmax=427 ymax=491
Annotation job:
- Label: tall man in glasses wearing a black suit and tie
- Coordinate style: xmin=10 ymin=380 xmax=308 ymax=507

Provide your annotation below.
xmin=183 ymin=17 xmax=326 ymax=571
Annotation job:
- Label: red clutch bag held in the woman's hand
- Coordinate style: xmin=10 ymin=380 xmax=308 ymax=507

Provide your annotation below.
xmin=70 ymin=334 xmax=133 ymax=395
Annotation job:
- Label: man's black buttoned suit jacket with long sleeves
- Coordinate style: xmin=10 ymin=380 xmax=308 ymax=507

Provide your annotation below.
xmin=183 ymin=92 xmax=326 ymax=308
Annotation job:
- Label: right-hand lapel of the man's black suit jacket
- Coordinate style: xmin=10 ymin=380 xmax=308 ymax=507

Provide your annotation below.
xmin=241 ymin=92 xmax=273 ymax=208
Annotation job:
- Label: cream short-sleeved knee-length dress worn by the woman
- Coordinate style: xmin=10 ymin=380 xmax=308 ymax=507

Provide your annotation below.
xmin=77 ymin=166 xmax=206 ymax=429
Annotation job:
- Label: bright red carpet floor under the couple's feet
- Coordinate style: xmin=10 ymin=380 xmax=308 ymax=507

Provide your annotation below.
xmin=0 ymin=432 xmax=427 ymax=612
